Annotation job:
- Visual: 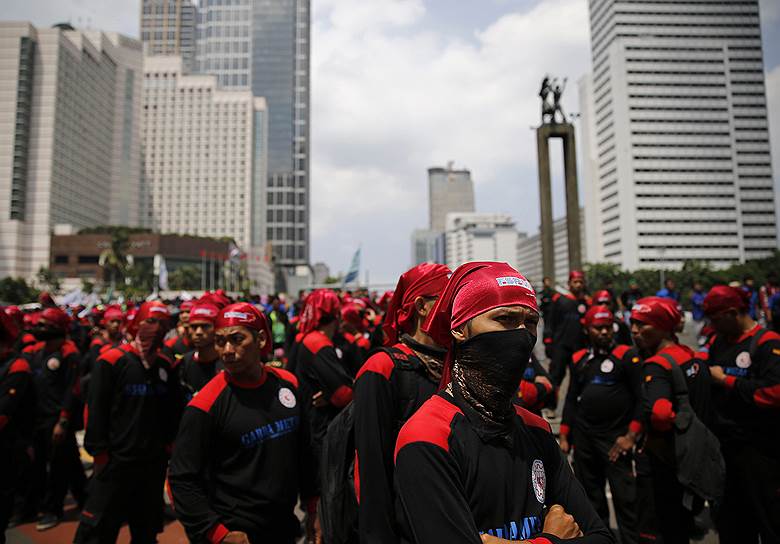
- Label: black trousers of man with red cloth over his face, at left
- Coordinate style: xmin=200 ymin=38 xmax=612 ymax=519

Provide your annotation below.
xmin=74 ymin=459 xmax=166 ymax=544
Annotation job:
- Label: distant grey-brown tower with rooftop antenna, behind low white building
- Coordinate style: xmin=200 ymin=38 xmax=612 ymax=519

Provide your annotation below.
xmin=428 ymin=163 xmax=474 ymax=232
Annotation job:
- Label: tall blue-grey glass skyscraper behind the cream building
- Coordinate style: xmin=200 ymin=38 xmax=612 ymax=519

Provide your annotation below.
xmin=197 ymin=0 xmax=311 ymax=270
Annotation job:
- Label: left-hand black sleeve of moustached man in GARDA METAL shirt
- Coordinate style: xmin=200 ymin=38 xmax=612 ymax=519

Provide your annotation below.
xmin=168 ymin=406 xmax=222 ymax=542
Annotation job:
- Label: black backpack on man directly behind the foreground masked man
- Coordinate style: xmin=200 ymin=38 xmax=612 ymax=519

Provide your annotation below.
xmin=319 ymin=347 xmax=423 ymax=544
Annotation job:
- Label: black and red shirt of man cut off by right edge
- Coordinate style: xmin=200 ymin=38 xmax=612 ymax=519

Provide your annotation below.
xmin=697 ymin=325 xmax=780 ymax=457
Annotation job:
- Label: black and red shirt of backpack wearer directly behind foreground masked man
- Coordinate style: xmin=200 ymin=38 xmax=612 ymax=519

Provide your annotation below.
xmin=354 ymin=342 xmax=439 ymax=543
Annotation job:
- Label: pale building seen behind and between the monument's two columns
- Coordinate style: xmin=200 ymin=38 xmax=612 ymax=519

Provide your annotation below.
xmin=517 ymin=210 xmax=588 ymax=289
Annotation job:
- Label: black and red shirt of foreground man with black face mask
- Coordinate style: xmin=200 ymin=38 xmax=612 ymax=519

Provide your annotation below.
xmin=395 ymin=392 xmax=614 ymax=544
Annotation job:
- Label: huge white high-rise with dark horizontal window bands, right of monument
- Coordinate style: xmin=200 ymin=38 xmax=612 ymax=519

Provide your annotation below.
xmin=580 ymin=0 xmax=777 ymax=269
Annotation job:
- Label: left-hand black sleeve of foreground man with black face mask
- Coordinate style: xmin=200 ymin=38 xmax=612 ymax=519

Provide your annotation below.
xmin=395 ymin=442 xmax=482 ymax=544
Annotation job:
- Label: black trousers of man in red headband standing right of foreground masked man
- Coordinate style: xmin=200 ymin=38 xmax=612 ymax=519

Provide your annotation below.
xmin=573 ymin=425 xmax=639 ymax=544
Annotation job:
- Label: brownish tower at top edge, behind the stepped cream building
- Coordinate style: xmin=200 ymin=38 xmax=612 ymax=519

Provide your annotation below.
xmin=140 ymin=0 xmax=197 ymax=73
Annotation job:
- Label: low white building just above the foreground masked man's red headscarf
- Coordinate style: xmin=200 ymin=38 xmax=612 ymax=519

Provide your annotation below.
xmin=445 ymin=213 xmax=518 ymax=270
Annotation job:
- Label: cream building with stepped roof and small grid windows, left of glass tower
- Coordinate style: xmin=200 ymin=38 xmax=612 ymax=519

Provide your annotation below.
xmin=141 ymin=56 xmax=268 ymax=288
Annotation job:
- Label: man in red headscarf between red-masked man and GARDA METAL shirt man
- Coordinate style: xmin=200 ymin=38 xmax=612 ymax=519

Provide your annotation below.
xmin=179 ymin=302 xmax=223 ymax=402
